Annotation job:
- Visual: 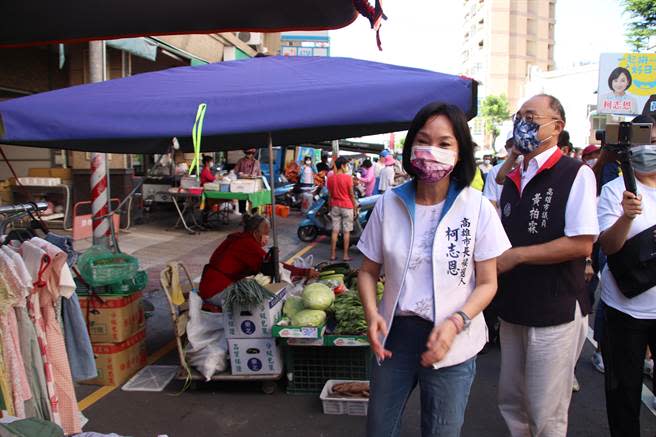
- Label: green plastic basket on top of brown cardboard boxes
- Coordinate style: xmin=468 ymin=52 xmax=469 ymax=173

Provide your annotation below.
xmin=78 ymin=246 xmax=139 ymax=287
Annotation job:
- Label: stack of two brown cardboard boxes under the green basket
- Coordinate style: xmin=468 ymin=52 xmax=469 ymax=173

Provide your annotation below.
xmin=80 ymin=291 xmax=147 ymax=386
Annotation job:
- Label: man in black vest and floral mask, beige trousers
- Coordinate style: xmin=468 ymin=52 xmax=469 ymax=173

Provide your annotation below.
xmin=497 ymin=94 xmax=599 ymax=437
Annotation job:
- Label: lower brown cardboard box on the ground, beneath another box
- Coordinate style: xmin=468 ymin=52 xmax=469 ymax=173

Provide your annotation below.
xmin=83 ymin=329 xmax=148 ymax=385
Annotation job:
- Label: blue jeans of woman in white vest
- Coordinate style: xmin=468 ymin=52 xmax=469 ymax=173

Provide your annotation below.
xmin=367 ymin=317 xmax=476 ymax=437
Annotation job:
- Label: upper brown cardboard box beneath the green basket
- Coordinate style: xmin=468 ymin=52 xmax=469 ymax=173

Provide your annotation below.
xmin=80 ymin=292 xmax=145 ymax=343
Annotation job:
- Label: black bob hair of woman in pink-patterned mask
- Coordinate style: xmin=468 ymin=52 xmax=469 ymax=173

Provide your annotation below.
xmin=403 ymin=102 xmax=476 ymax=188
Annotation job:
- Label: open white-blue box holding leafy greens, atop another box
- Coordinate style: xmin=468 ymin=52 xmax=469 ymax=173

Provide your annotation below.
xmin=225 ymin=284 xmax=286 ymax=339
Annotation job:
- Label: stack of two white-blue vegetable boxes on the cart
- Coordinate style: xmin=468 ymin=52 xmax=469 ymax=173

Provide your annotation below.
xmin=226 ymin=284 xmax=286 ymax=375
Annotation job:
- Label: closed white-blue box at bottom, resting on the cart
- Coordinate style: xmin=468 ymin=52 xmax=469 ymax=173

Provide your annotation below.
xmin=228 ymin=338 xmax=282 ymax=375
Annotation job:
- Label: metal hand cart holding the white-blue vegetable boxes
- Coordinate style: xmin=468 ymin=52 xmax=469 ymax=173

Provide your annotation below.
xmin=160 ymin=262 xmax=283 ymax=394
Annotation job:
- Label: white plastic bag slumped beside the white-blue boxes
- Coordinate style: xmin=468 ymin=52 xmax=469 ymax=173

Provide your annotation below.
xmin=185 ymin=292 xmax=228 ymax=381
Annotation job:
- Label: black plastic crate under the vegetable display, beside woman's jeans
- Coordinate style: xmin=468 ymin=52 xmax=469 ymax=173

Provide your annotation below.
xmin=285 ymin=345 xmax=372 ymax=394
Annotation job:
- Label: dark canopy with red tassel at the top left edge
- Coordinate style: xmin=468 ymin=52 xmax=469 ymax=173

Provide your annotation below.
xmin=0 ymin=0 xmax=382 ymax=47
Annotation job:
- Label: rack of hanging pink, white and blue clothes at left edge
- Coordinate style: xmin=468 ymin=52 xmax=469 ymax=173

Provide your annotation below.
xmin=0 ymin=205 xmax=97 ymax=435
